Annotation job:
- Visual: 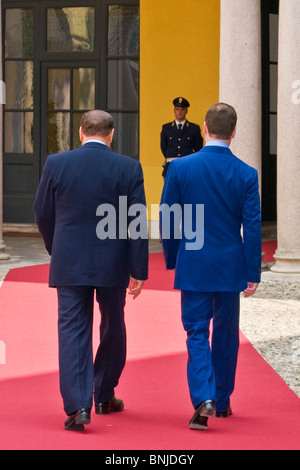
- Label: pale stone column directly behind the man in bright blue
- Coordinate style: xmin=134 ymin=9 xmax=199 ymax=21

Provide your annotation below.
xmin=219 ymin=0 xmax=261 ymax=180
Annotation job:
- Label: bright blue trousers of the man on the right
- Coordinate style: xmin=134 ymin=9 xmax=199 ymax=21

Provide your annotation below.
xmin=181 ymin=291 xmax=240 ymax=412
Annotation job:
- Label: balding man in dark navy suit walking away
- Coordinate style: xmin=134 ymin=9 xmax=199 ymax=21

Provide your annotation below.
xmin=34 ymin=110 xmax=148 ymax=430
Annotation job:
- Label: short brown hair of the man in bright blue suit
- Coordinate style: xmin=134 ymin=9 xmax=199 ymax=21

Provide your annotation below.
xmin=205 ymin=103 xmax=237 ymax=140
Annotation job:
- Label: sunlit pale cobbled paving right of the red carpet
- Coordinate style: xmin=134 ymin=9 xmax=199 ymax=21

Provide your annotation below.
xmin=240 ymin=272 xmax=300 ymax=398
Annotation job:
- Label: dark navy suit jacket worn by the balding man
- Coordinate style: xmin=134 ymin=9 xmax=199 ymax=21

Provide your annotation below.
xmin=34 ymin=142 xmax=148 ymax=287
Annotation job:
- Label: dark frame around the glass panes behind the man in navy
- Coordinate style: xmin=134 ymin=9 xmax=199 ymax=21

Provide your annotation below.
xmin=2 ymin=0 xmax=140 ymax=223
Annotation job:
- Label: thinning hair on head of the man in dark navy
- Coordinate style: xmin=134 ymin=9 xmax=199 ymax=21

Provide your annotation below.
xmin=80 ymin=109 xmax=114 ymax=137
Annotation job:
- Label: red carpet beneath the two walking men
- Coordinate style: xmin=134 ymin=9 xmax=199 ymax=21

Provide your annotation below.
xmin=0 ymin=244 xmax=300 ymax=451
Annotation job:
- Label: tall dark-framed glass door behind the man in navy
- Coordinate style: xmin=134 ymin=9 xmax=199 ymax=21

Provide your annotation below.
xmin=1 ymin=0 xmax=139 ymax=224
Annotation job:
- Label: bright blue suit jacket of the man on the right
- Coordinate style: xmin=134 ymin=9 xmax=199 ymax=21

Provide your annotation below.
xmin=160 ymin=146 xmax=261 ymax=292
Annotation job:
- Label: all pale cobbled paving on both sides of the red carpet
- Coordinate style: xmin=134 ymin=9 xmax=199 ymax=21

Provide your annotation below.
xmin=0 ymin=236 xmax=300 ymax=398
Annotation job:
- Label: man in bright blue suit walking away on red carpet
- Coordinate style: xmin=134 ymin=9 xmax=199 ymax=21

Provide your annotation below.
xmin=160 ymin=103 xmax=261 ymax=429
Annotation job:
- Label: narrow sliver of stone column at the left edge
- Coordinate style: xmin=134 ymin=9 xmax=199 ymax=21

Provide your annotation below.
xmin=0 ymin=1 xmax=9 ymax=261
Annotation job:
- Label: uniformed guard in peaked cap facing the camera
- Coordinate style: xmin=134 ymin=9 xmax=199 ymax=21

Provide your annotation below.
xmin=160 ymin=97 xmax=203 ymax=177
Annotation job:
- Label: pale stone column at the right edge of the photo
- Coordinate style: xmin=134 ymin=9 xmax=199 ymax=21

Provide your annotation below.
xmin=272 ymin=0 xmax=300 ymax=274
